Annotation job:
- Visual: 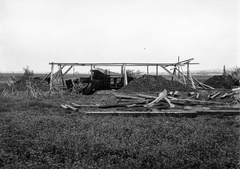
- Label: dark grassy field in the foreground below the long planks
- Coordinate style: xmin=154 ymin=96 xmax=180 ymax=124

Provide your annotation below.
xmin=0 ymin=97 xmax=240 ymax=168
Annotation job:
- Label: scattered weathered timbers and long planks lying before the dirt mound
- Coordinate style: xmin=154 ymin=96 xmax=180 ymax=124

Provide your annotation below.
xmin=61 ymin=89 xmax=240 ymax=117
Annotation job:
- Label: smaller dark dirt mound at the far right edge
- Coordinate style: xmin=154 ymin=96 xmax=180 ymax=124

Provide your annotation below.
xmin=204 ymin=75 xmax=239 ymax=89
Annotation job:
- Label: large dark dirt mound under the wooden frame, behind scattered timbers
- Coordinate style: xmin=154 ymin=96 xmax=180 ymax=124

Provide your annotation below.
xmin=118 ymin=75 xmax=194 ymax=92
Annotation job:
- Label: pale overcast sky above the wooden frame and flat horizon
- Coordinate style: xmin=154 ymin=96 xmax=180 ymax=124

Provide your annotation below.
xmin=0 ymin=0 xmax=240 ymax=72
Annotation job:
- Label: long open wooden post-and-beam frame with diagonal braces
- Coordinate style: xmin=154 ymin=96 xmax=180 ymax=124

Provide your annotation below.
xmin=45 ymin=58 xmax=210 ymax=90
